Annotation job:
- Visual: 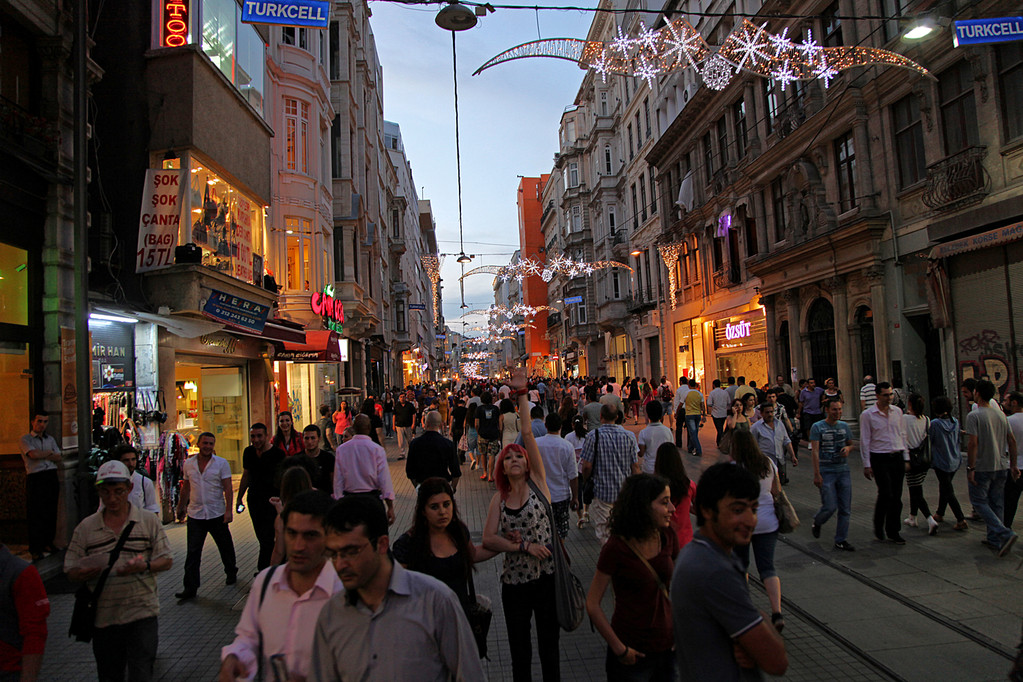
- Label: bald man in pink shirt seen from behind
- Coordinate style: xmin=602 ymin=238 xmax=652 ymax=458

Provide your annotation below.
xmin=333 ymin=414 xmax=394 ymax=525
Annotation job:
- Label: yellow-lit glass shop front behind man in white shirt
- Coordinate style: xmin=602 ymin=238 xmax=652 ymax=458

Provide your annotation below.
xmin=174 ymin=362 xmax=249 ymax=473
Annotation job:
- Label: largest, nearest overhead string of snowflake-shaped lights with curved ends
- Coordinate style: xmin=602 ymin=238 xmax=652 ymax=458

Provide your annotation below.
xmin=473 ymin=18 xmax=930 ymax=90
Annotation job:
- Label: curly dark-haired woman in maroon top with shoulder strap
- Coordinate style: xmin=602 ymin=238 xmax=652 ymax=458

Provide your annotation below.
xmin=586 ymin=473 xmax=678 ymax=682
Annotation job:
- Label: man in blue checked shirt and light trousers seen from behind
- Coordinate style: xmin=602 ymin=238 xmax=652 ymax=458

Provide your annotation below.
xmin=580 ymin=404 xmax=639 ymax=544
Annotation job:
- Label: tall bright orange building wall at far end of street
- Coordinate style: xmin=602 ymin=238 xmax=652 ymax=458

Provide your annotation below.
xmin=517 ymin=174 xmax=550 ymax=372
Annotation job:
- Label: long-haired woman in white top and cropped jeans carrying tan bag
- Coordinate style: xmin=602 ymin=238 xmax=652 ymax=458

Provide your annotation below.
xmin=731 ymin=430 xmax=785 ymax=632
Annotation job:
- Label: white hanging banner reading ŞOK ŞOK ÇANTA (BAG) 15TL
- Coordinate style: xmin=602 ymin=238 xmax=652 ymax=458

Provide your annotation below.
xmin=135 ymin=169 xmax=186 ymax=272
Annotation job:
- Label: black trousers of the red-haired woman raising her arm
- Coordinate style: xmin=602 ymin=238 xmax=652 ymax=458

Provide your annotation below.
xmin=501 ymin=574 xmax=562 ymax=682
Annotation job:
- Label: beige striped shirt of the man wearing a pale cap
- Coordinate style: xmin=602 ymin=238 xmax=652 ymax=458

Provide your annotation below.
xmin=64 ymin=504 xmax=171 ymax=628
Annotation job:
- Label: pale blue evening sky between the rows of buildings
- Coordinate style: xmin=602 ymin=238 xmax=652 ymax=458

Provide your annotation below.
xmin=369 ymin=0 xmax=595 ymax=331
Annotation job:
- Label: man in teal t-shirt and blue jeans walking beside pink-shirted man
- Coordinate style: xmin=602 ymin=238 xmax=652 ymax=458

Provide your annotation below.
xmin=810 ymin=400 xmax=855 ymax=552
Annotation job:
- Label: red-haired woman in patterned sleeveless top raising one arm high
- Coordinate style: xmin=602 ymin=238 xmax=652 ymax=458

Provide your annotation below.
xmin=483 ymin=369 xmax=562 ymax=682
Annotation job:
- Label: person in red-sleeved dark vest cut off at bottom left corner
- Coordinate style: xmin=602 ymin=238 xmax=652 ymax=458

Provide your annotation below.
xmin=0 ymin=542 xmax=50 ymax=682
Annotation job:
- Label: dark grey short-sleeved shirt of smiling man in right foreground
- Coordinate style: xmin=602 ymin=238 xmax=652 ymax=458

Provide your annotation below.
xmin=671 ymin=534 xmax=763 ymax=682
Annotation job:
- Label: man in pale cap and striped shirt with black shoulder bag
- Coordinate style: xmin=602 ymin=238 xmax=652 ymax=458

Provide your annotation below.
xmin=64 ymin=460 xmax=172 ymax=682
